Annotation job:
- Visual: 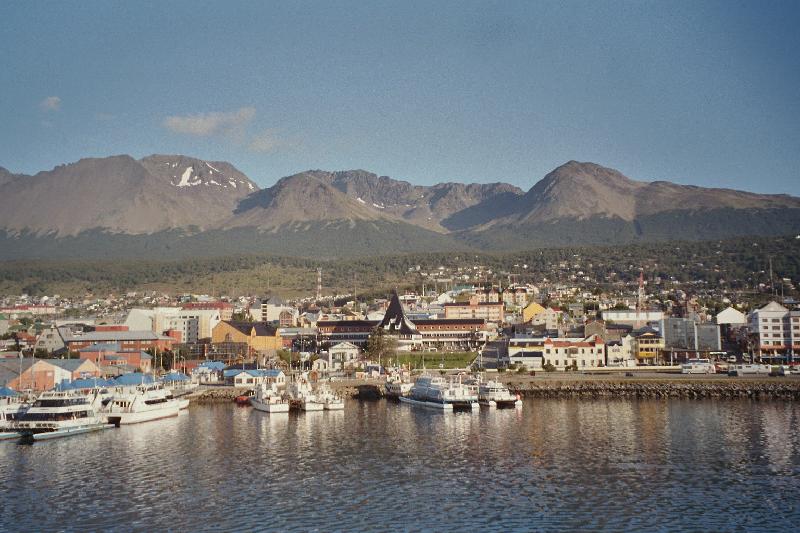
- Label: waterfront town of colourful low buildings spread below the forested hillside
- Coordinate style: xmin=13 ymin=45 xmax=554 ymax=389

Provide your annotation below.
xmin=0 ymin=251 xmax=800 ymax=392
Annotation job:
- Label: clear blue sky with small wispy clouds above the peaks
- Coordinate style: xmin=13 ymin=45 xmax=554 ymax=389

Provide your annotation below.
xmin=0 ymin=0 xmax=800 ymax=194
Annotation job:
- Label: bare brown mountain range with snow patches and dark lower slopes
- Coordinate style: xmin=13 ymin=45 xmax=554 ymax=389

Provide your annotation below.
xmin=0 ymin=155 xmax=800 ymax=259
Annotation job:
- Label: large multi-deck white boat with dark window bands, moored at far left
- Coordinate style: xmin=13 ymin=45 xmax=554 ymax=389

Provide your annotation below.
xmin=15 ymin=390 xmax=113 ymax=442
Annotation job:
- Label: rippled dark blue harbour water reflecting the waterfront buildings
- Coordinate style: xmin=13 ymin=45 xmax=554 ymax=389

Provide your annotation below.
xmin=0 ymin=400 xmax=800 ymax=531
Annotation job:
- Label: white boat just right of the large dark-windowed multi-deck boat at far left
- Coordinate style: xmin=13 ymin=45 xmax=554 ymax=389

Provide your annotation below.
xmin=105 ymin=384 xmax=180 ymax=426
